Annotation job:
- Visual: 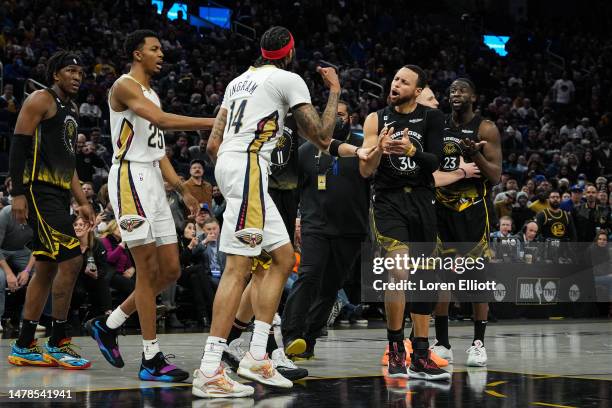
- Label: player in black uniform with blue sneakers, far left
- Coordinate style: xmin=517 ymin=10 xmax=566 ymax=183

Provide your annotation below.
xmin=8 ymin=51 xmax=95 ymax=370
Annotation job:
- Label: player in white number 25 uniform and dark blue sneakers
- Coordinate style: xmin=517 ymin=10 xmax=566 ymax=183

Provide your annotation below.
xmin=87 ymin=30 xmax=213 ymax=382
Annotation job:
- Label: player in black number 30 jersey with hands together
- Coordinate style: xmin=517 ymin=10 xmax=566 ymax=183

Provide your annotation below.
xmin=360 ymin=65 xmax=450 ymax=380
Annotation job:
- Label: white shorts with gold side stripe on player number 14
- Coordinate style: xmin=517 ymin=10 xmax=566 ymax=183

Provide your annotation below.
xmin=215 ymin=152 xmax=291 ymax=257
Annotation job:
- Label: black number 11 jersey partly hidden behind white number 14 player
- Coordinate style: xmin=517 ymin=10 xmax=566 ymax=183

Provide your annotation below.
xmin=268 ymin=114 xmax=300 ymax=190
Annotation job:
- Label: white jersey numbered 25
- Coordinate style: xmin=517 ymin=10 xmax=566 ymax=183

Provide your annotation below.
xmin=108 ymin=75 xmax=166 ymax=163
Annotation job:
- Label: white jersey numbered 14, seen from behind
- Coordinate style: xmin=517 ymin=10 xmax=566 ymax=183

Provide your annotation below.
xmin=218 ymin=65 xmax=310 ymax=163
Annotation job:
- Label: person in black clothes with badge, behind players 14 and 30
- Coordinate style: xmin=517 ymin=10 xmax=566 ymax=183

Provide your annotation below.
xmin=282 ymin=101 xmax=370 ymax=358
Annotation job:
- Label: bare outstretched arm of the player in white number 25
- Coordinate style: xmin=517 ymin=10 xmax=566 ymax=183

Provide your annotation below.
xmin=111 ymin=77 xmax=214 ymax=130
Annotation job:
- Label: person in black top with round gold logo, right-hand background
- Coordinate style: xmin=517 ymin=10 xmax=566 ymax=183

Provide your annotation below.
xmin=536 ymin=190 xmax=576 ymax=242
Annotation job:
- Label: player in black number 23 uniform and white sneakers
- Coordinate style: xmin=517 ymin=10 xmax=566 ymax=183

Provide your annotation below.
xmin=432 ymin=78 xmax=502 ymax=366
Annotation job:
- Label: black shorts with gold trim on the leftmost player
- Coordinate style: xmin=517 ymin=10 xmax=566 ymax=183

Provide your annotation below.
xmin=26 ymin=183 xmax=81 ymax=262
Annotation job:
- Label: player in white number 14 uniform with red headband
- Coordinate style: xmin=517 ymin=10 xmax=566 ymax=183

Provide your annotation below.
xmin=192 ymin=27 xmax=369 ymax=398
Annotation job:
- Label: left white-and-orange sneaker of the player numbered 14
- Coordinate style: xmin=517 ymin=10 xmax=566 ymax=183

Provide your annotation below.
xmin=191 ymin=366 xmax=255 ymax=398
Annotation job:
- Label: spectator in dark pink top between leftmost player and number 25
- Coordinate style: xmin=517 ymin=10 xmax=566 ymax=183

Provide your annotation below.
xmin=100 ymin=220 xmax=136 ymax=303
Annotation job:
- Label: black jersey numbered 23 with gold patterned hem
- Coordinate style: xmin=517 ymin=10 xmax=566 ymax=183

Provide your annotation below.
xmin=436 ymin=114 xmax=490 ymax=211
